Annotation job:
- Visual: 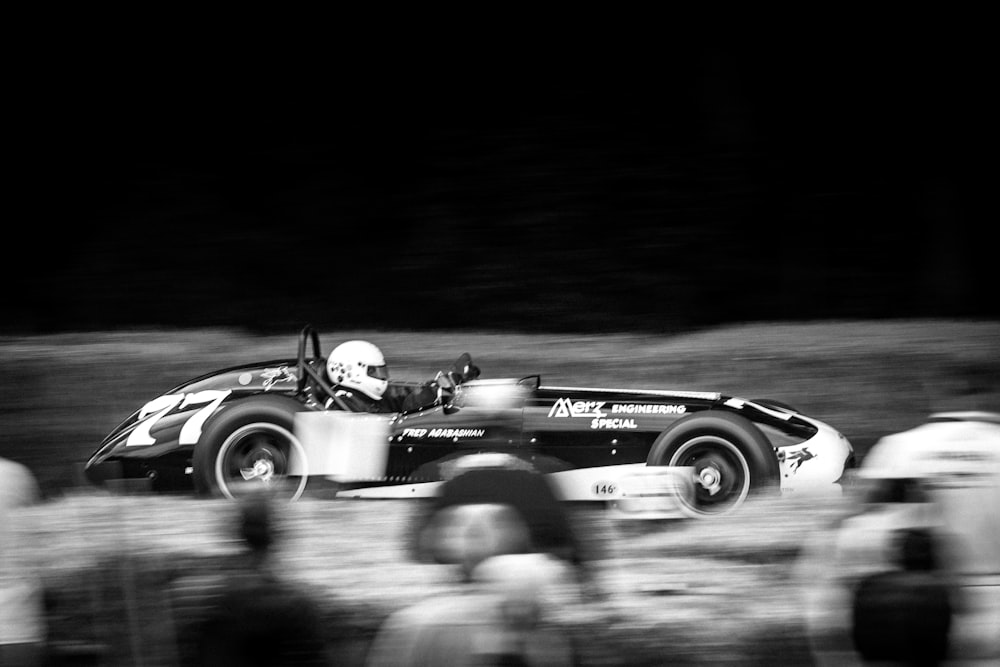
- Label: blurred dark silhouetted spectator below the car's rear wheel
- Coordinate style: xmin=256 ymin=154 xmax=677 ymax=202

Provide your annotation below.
xmin=188 ymin=495 xmax=331 ymax=667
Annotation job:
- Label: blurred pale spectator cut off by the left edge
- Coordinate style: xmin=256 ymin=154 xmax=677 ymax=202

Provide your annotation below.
xmin=0 ymin=459 xmax=46 ymax=667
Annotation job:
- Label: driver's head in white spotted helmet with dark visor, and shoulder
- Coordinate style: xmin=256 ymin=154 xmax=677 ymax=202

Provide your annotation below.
xmin=326 ymin=340 xmax=396 ymax=412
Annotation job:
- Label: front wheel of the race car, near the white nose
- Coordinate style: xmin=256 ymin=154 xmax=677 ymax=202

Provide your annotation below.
xmin=646 ymin=410 xmax=780 ymax=518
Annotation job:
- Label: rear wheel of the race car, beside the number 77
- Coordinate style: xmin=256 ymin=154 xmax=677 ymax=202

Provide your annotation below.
xmin=192 ymin=396 xmax=308 ymax=500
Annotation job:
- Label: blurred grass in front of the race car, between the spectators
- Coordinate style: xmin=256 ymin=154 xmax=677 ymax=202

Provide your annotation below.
xmin=5 ymin=482 xmax=844 ymax=665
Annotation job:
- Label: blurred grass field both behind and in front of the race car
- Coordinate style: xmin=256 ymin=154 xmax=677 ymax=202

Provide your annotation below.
xmin=0 ymin=321 xmax=1000 ymax=665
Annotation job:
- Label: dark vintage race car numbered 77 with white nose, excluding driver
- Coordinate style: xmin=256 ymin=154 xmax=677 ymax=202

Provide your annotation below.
xmin=86 ymin=327 xmax=852 ymax=516
